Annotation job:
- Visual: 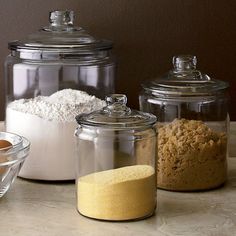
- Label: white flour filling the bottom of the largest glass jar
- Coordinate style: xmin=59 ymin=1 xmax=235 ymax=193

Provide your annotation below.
xmin=6 ymin=89 xmax=105 ymax=180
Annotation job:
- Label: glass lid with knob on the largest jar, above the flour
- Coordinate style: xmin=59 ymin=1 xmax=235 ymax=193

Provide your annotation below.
xmin=8 ymin=11 xmax=112 ymax=59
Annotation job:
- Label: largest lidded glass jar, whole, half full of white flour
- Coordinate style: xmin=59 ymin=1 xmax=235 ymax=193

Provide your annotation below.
xmin=5 ymin=11 xmax=115 ymax=180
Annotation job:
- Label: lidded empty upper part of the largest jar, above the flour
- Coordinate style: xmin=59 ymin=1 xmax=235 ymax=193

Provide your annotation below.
xmin=5 ymin=11 xmax=115 ymax=102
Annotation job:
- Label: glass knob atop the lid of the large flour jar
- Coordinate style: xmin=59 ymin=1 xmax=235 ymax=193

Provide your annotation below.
xmin=49 ymin=11 xmax=74 ymax=27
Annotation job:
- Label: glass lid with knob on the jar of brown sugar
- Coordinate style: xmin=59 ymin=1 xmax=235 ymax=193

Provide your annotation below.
xmin=142 ymin=55 xmax=229 ymax=96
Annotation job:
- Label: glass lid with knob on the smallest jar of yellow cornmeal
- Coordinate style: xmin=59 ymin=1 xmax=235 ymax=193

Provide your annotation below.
xmin=76 ymin=94 xmax=157 ymax=130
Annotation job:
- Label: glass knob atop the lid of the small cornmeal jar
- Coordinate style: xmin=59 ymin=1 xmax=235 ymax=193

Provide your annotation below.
xmin=104 ymin=94 xmax=131 ymax=115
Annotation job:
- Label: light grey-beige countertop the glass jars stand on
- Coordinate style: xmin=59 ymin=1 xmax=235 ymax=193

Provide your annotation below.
xmin=0 ymin=122 xmax=236 ymax=236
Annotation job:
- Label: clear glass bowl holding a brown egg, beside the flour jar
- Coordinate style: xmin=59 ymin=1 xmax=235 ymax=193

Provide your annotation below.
xmin=0 ymin=132 xmax=30 ymax=198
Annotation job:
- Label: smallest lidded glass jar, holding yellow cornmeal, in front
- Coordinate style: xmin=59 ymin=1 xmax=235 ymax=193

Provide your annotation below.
xmin=75 ymin=94 xmax=156 ymax=221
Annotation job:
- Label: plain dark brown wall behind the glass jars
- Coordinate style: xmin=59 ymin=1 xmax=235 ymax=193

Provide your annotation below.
xmin=0 ymin=0 xmax=236 ymax=120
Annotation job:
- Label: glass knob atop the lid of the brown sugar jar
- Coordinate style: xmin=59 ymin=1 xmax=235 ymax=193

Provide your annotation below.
xmin=173 ymin=55 xmax=197 ymax=71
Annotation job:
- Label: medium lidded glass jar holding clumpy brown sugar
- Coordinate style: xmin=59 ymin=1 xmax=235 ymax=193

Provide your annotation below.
xmin=139 ymin=55 xmax=229 ymax=191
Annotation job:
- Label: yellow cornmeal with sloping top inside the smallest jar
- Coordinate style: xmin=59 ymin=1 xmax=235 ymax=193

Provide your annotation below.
xmin=77 ymin=165 xmax=156 ymax=221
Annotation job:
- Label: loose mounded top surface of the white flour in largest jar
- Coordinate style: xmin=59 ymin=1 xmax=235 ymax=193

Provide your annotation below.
xmin=8 ymin=89 xmax=105 ymax=121
